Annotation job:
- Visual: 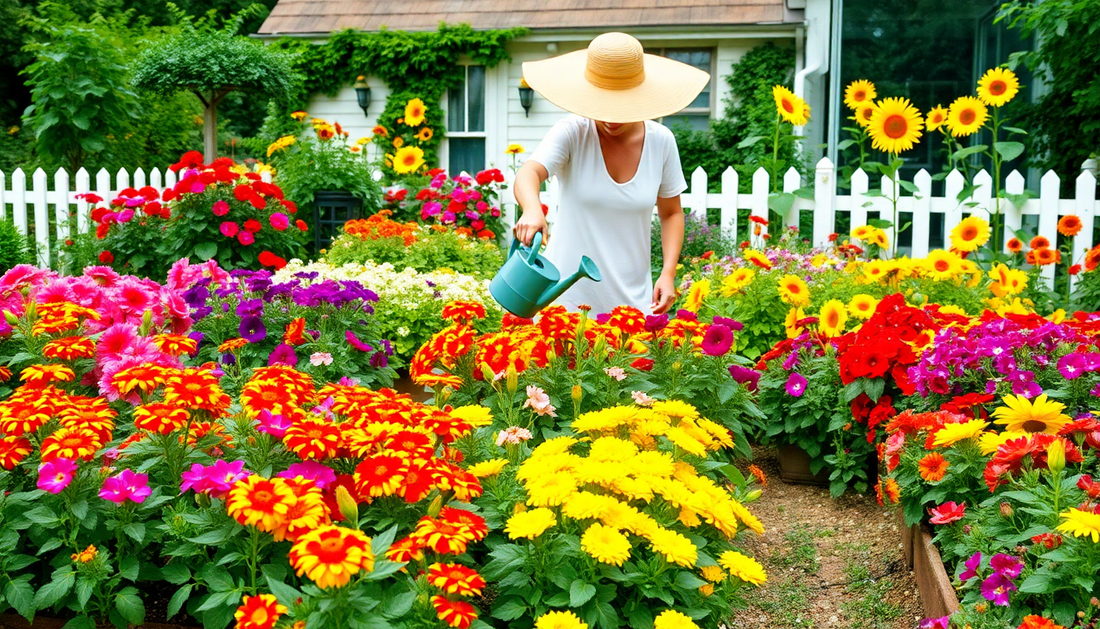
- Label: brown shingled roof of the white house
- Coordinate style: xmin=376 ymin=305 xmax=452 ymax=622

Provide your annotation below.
xmin=259 ymin=0 xmax=802 ymax=35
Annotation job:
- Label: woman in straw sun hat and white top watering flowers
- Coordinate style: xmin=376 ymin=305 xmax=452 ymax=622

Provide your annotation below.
xmin=514 ymin=33 xmax=711 ymax=315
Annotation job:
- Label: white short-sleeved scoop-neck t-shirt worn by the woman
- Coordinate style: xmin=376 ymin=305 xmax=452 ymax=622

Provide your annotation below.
xmin=530 ymin=115 xmax=688 ymax=315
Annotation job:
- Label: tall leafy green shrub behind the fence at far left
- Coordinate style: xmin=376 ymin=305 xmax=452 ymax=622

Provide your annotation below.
xmin=21 ymin=3 xmax=138 ymax=172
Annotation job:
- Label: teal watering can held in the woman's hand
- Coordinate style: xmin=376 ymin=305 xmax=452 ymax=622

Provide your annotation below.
xmin=488 ymin=232 xmax=603 ymax=319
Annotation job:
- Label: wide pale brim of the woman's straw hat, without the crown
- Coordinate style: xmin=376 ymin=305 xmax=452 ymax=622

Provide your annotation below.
xmin=524 ymin=49 xmax=711 ymax=122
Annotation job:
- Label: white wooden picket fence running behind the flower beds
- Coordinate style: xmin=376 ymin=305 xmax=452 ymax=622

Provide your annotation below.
xmin=0 ymin=158 xmax=1100 ymax=279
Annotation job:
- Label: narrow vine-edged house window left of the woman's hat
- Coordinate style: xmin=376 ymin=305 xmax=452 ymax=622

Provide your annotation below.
xmin=447 ymin=66 xmax=485 ymax=175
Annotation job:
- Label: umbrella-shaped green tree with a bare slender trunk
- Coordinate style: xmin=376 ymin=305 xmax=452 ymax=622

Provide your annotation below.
xmin=132 ymin=12 xmax=297 ymax=163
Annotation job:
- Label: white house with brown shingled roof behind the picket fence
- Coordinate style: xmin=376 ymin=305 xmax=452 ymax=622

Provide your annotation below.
xmin=256 ymin=0 xmax=1032 ymax=181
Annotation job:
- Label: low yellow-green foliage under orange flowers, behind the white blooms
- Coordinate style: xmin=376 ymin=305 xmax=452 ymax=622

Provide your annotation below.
xmin=323 ymin=223 xmax=504 ymax=279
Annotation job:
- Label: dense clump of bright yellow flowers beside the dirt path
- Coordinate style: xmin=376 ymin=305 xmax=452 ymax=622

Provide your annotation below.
xmin=505 ymin=400 xmax=767 ymax=595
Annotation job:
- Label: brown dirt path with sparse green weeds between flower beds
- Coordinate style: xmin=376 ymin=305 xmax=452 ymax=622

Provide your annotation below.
xmin=732 ymin=448 xmax=922 ymax=629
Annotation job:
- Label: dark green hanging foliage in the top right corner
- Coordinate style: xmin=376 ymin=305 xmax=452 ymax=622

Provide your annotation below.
xmin=998 ymin=0 xmax=1100 ymax=190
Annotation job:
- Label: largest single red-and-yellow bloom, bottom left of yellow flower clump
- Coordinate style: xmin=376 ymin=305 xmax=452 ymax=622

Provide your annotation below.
xmin=287 ymin=525 xmax=374 ymax=588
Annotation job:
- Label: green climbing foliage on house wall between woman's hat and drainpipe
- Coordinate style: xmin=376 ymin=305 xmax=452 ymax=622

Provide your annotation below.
xmin=673 ymin=42 xmax=799 ymax=192
